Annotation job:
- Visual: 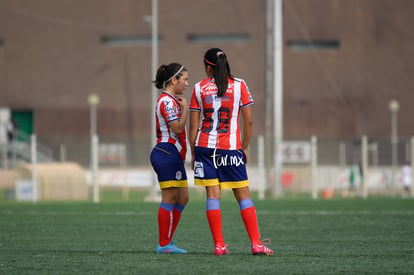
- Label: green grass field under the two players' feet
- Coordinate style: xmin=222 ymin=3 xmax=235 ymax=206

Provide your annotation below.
xmin=0 ymin=194 xmax=414 ymax=274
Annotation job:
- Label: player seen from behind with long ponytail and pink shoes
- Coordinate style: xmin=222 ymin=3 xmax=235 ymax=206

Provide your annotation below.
xmin=189 ymin=48 xmax=273 ymax=255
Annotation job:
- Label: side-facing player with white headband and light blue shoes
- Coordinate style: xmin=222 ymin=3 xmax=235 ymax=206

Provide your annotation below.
xmin=150 ymin=63 xmax=188 ymax=254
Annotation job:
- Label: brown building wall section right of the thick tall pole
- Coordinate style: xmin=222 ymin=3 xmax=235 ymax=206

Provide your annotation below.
xmin=284 ymin=0 xmax=414 ymax=138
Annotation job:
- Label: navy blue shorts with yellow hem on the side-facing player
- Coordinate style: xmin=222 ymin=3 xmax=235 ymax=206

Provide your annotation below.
xmin=150 ymin=142 xmax=188 ymax=189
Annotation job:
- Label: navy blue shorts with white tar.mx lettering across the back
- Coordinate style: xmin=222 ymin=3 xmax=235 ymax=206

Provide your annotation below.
xmin=194 ymin=147 xmax=249 ymax=189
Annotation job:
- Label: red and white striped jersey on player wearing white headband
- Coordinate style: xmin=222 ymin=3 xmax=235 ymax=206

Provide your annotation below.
xmin=155 ymin=91 xmax=187 ymax=160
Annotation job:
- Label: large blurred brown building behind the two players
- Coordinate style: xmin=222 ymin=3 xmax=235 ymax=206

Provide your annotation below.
xmin=0 ymin=0 xmax=414 ymax=165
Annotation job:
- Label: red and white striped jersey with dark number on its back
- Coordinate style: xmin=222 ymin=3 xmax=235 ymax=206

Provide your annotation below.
xmin=190 ymin=77 xmax=253 ymax=150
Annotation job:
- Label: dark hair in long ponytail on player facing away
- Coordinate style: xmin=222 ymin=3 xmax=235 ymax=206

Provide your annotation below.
xmin=204 ymin=48 xmax=233 ymax=97
